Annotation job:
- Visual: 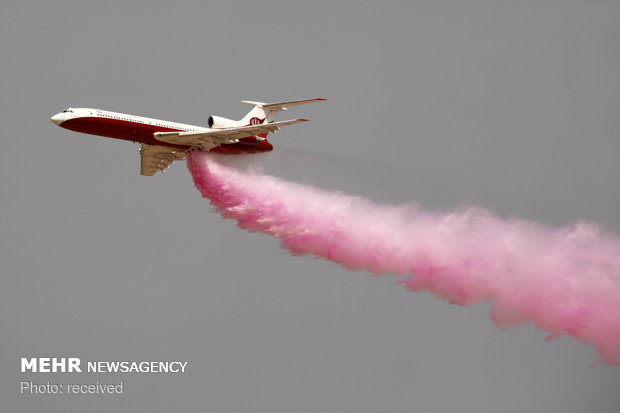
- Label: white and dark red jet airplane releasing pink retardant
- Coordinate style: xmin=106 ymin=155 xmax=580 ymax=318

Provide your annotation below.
xmin=50 ymin=98 xmax=325 ymax=176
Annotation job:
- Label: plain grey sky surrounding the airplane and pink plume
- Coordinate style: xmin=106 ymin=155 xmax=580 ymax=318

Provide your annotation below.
xmin=0 ymin=0 xmax=620 ymax=413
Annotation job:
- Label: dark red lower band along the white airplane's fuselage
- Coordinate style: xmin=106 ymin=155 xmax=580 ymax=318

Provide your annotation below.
xmin=60 ymin=116 xmax=273 ymax=154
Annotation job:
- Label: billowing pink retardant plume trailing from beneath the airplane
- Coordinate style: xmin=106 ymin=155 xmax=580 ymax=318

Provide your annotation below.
xmin=187 ymin=151 xmax=620 ymax=365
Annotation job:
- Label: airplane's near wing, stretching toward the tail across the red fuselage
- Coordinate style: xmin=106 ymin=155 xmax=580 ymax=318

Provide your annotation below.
xmin=154 ymin=119 xmax=307 ymax=151
